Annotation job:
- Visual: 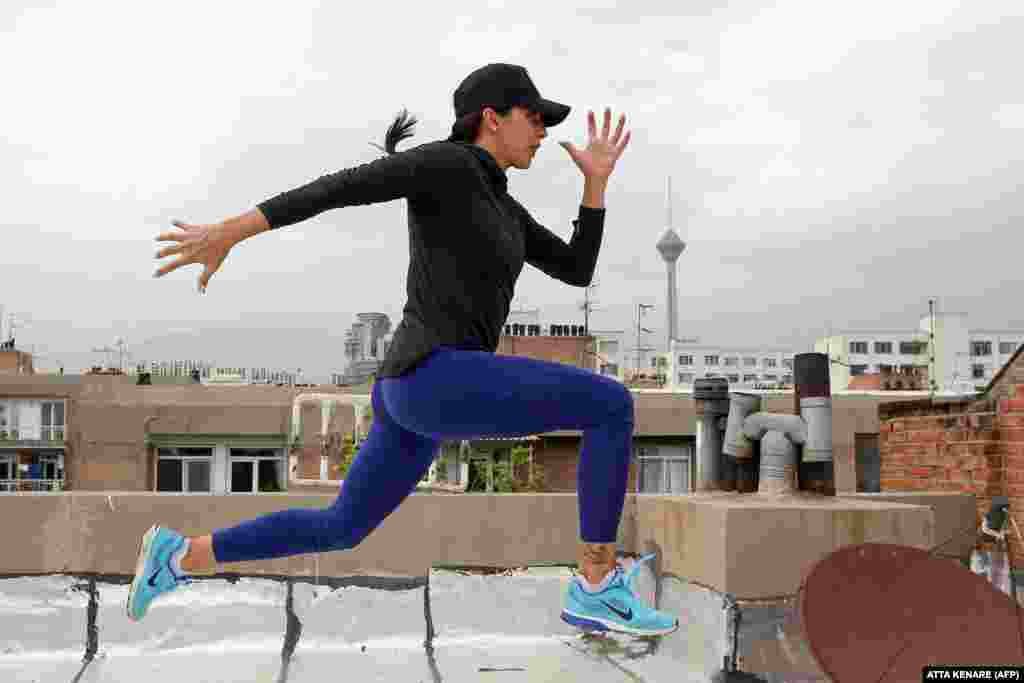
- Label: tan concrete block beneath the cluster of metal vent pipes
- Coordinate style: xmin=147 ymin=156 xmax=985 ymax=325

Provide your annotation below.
xmin=636 ymin=492 xmax=935 ymax=600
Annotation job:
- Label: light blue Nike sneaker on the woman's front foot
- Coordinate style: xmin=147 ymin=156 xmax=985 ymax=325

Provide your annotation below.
xmin=562 ymin=555 xmax=679 ymax=636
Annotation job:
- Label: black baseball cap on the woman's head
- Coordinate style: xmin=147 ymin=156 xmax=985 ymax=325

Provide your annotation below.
xmin=453 ymin=63 xmax=570 ymax=139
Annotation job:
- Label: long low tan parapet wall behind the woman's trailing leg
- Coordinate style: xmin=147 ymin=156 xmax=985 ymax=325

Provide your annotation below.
xmin=0 ymin=492 xmax=606 ymax=577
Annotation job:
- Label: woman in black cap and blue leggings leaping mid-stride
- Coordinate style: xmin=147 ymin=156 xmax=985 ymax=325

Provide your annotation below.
xmin=134 ymin=63 xmax=679 ymax=635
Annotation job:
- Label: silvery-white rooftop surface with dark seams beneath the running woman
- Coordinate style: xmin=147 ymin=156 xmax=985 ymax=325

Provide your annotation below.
xmin=0 ymin=567 xmax=782 ymax=683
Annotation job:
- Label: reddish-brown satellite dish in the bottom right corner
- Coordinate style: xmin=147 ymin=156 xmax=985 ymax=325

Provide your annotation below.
xmin=793 ymin=543 xmax=1024 ymax=683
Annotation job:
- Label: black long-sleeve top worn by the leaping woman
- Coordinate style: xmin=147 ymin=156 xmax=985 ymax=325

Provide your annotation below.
xmin=258 ymin=141 xmax=604 ymax=378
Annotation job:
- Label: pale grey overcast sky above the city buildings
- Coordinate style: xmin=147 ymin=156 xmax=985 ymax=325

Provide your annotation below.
xmin=0 ymin=0 xmax=1024 ymax=379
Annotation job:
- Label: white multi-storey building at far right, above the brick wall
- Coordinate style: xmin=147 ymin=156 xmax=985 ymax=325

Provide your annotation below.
xmin=814 ymin=312 xmax=1024 ymax=393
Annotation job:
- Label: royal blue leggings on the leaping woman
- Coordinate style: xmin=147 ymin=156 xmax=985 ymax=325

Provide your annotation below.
xmin=213 ymin=347 xmax=633 ymax=562
